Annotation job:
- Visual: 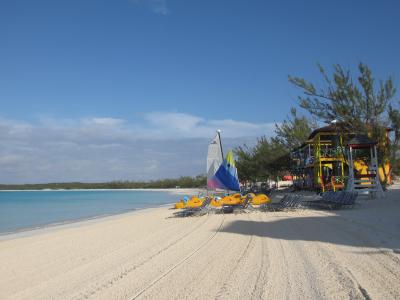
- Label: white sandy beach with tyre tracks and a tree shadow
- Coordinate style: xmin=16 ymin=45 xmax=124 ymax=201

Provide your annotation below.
xmin=0 ymin=190 xmax=400 ymax=299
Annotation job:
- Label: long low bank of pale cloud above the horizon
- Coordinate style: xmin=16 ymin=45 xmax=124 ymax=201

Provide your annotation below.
xmin=0 ymin=112 xmax=274 ymax=183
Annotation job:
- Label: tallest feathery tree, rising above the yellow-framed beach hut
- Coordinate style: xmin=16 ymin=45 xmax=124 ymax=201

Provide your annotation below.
xmin=289 ymin=63 xmax=397 ymax=182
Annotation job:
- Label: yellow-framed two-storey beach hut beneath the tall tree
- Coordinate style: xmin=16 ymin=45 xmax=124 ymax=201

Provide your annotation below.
xmin=291 ymin=124 xmax=391 ymax=192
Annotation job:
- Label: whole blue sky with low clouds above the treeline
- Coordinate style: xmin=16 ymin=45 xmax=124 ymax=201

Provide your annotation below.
xmin=0 ymin=0 xmax=400 ymax=182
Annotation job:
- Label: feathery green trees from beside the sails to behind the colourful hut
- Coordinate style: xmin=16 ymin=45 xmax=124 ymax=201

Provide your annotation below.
xmin=235 ymin=63 xmax=400 ymax=182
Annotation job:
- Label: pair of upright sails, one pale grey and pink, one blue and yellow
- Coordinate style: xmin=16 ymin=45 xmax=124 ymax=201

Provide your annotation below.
xmin=207 ymin=134 xmax=240 ymax=191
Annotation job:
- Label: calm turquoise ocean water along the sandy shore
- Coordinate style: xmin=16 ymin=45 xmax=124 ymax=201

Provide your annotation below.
xmin=0 ymin=190 xmax=179 ymax=234
